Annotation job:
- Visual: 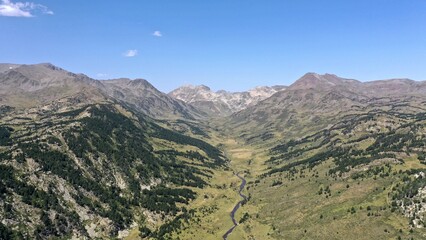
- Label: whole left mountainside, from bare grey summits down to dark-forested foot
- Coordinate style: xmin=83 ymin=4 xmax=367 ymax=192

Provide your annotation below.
xmin=0 ymin=64 xmax=230 ymax=239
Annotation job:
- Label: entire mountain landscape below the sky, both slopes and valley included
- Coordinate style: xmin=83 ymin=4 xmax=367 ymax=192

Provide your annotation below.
xmin=0 ymin=63 xmax=426 ymax=239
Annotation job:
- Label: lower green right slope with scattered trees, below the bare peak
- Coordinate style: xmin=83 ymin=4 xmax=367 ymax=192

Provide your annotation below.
xmin=249 ymin=109 xmax=426 ymax=239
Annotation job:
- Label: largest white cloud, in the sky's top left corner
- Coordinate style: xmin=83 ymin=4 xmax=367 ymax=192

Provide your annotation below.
xmin=0 ymin=0 xmax=53 ymax=17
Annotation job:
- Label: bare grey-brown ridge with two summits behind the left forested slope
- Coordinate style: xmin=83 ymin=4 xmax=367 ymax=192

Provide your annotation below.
xmin=0 ymin=63 xmax=204 ymax=119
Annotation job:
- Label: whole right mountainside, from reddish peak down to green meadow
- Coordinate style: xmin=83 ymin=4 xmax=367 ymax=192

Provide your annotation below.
xmin=206 ymin=73 xmax=426 ymax=239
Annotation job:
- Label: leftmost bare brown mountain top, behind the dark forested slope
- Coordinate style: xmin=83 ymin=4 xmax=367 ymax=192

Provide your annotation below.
xmin=0 ymin=63 xmax=106 ymax=108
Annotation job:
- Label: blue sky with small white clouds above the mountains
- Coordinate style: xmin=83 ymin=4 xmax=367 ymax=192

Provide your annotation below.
xmin=0 ymin=0 xmax=426 ymax=92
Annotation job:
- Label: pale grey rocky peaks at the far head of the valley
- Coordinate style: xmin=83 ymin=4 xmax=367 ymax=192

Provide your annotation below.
xmin=169 ymin=85 xmax=286 ymax=116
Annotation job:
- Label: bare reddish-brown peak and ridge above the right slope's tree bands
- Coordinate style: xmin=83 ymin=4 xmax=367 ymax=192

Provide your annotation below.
xmin=228 ymin=73 xmax=426 ymax=141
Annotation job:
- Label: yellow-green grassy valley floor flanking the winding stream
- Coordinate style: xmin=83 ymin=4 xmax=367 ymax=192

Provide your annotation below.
xmin=126 ymin=138 xmax=273 ymax=240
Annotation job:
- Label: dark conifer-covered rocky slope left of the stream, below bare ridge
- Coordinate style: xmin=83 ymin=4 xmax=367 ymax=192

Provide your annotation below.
xmin=0 ymin=103 xmax=224 ymax=239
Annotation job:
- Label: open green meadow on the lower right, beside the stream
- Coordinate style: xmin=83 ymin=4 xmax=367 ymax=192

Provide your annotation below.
xmin=249 ymin=160 xmax=426 ymax=239
